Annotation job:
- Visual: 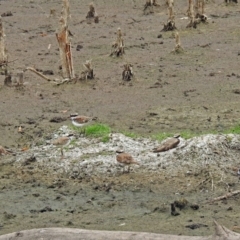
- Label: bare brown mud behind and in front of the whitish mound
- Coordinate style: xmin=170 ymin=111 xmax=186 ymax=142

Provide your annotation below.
xmin=0 ymin=0 xmax=240 ymax=235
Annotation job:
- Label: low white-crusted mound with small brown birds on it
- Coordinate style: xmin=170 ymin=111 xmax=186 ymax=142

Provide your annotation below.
xmin=11 ymin=126 xmax=240 ymax=177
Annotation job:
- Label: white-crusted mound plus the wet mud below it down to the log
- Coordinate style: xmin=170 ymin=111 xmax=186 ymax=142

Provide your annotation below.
xmin=0 ymin=126 xmax=240 ymax=236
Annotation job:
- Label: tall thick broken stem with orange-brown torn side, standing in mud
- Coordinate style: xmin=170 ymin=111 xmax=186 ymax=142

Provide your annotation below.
xmin=56 ymin=0 xmax=75 ymax=79
